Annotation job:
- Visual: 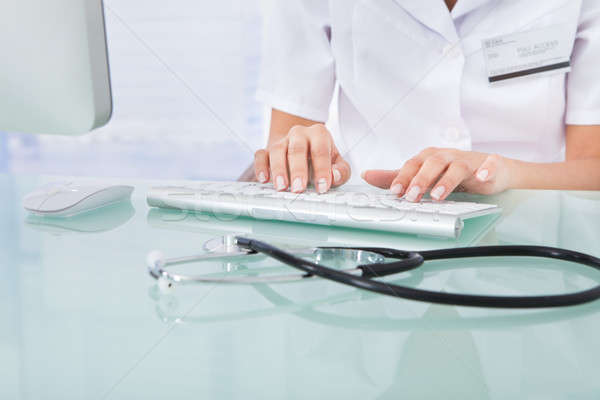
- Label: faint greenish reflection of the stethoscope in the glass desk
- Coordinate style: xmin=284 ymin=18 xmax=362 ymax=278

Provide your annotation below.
xmin=148 ymin=256 xmax=600 ymax=331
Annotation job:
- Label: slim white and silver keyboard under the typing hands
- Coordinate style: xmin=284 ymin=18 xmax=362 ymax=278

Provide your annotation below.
xmin=147 ymin=182 xmax=501 ymax=238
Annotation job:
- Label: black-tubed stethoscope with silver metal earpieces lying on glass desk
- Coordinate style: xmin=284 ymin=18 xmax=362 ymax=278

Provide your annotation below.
xmin=147 ymin=236 xmax=600 ymax=308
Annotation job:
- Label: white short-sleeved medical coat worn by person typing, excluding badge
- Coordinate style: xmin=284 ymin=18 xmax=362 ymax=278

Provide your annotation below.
xmin=258 ymin=0 xmax=600 ymax=183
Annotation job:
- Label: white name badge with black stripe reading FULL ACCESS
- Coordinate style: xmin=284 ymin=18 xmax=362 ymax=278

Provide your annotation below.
xmin=483 ymin=25 xmax=575 ymax=83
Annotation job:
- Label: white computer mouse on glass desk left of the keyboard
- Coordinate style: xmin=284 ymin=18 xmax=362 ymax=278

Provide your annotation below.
xmin=23 ymin=182 xmax=133 ymax=217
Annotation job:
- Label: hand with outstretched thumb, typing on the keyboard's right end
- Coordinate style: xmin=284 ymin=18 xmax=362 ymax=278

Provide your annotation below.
xmin=362 ymin=147 xmax=510 ymax=202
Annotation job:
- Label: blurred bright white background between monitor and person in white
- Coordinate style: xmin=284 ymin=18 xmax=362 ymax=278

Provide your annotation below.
xmin=0 ymin=0 xmax=266 ymax=180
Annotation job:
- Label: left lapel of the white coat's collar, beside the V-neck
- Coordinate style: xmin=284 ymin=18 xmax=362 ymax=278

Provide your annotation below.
xmin=394 ymin=0 xmax=460 ymax=43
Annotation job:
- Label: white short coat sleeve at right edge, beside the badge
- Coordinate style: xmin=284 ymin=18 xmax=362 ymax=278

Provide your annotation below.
xmin=565 ymin=0 xmax=600 ymax=125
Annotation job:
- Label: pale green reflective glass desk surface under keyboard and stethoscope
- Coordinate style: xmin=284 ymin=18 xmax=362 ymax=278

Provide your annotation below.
xmin=0 ymin=175 xmax=600 ymax=399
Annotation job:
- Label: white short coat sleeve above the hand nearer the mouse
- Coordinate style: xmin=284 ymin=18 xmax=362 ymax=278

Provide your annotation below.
xmin=257 ymin=0 xmax=335 ymax=122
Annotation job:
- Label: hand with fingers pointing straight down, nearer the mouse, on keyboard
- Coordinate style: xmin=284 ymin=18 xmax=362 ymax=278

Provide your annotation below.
xmin=254 ymin=124 xmax=350 ymax=193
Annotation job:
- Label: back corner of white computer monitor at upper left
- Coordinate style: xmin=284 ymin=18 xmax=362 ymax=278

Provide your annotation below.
xmin=0 ymin=0 xmax=112 ymax=135
